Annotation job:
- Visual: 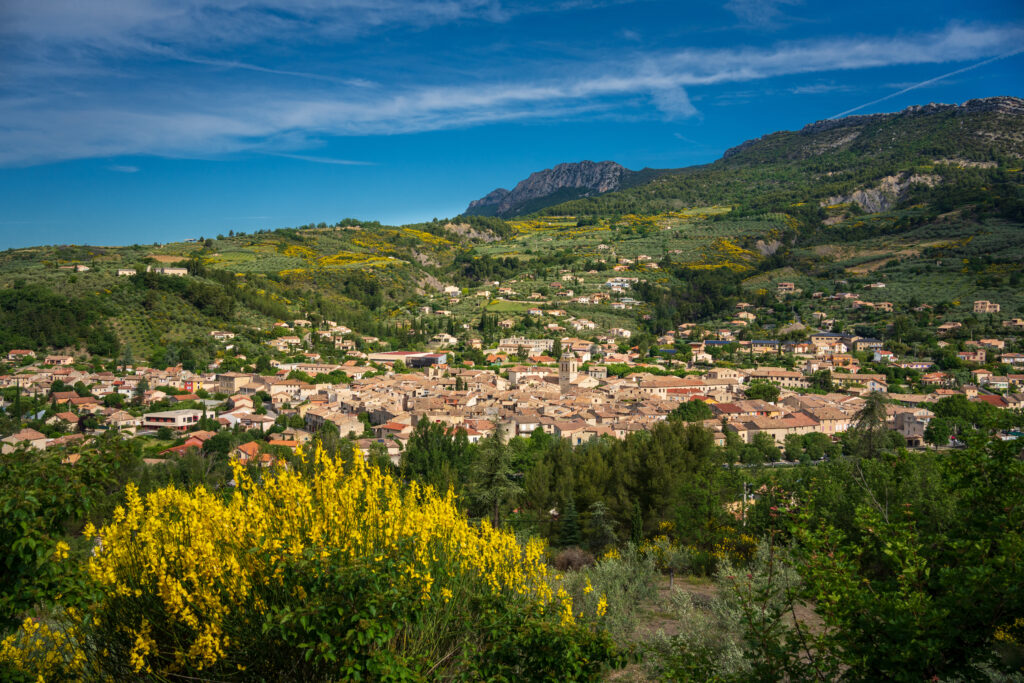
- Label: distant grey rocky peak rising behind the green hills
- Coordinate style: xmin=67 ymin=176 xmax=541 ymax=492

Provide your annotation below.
xmin=465 ymin=161 xmax=664 ymax=217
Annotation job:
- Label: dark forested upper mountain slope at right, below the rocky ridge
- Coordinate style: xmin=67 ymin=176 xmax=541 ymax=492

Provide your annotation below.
xmin=539 ymin=97 xmax=1024 ymax=220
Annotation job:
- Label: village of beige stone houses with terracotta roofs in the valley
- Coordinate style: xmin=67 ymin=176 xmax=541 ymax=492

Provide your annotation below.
xmin=0 ymin=283 xmax=1024 ymax=466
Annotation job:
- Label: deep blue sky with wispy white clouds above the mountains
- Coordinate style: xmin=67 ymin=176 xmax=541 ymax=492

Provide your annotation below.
xmin=0 ymin=0 xmax=1024 ymax=248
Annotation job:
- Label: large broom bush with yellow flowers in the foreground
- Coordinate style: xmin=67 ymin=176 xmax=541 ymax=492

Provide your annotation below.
xmin=3 ymin=451 xmax=616 ymax=680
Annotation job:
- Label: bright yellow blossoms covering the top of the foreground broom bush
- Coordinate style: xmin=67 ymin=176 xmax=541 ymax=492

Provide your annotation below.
xmin=0 ymin=450 xmax=581 ymax=680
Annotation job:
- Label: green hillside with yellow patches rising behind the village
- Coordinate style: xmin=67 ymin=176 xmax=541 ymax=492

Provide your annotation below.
xmin=0 ymin=98 xmax=1024 ymax=359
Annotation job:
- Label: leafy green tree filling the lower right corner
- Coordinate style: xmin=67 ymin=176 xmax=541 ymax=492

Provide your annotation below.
xmin=774 ymin=440 xmax=1024 ymax=681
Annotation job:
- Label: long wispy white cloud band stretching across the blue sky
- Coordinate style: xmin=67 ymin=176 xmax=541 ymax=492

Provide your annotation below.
xmin=0 ymin=20 xmax=1024 ymax=166
